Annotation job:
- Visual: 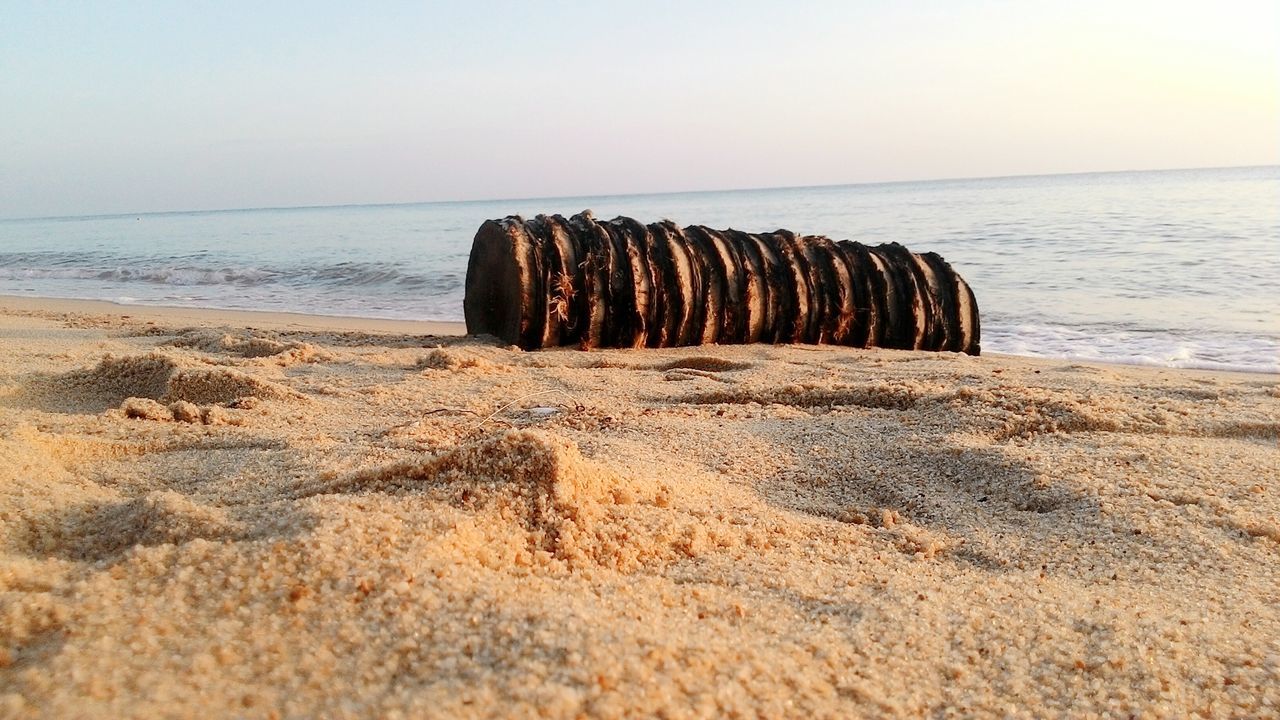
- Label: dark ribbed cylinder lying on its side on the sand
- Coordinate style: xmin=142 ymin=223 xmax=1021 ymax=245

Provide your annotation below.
xmin=463 ymin=211 xmax=980 ymax=355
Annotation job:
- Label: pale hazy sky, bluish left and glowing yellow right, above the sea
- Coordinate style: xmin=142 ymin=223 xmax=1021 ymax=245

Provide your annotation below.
xmin=0 ymin=0 xmax=1280 ymax=218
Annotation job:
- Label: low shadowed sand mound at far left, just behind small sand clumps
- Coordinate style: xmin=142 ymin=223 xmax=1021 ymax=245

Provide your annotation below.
xmin=46 ymin=352 xmax=303 ymax=416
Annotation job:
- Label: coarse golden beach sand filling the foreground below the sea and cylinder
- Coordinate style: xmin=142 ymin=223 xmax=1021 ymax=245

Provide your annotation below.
xmin=0 ymin=299 xmax=1280 ymax=717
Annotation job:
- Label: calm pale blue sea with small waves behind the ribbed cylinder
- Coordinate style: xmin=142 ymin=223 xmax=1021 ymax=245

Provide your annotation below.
xmin=0 ymin=167 xmax=1280 ymax=373
